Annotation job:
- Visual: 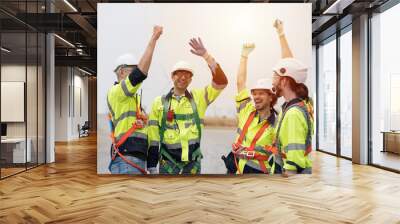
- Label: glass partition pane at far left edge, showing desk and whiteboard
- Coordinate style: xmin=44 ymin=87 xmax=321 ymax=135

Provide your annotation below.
xmin=0 ymin=32 xmax=30 ymax=178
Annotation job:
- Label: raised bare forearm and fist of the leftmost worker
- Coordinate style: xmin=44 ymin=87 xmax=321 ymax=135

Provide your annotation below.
xmin=138 ymin=26 xmax=163 ymax=75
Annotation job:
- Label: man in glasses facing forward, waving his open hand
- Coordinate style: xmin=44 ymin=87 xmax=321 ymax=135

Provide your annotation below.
xmin=147 ymin=38 xmax=228 ymax=174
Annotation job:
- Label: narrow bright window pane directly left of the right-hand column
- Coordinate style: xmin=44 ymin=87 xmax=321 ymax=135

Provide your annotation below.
xmin=340 ymin=30 xmax=353 ymax=158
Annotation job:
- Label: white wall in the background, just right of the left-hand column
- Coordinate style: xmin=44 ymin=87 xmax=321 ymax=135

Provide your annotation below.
xmin=55 ymin=67 xmax=88 ymax=141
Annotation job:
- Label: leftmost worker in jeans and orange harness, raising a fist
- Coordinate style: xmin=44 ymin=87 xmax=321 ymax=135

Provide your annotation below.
xmin=107 ymin=26 xmax=163 ymax=174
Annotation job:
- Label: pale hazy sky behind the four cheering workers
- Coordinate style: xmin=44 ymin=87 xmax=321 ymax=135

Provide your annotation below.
xmin=97 ymin=3 xmax=314 ymax=117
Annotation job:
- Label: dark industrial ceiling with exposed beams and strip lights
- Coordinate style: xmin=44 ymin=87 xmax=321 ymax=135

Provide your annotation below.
xmin=0 ymin=0 xmax=388 ymax=73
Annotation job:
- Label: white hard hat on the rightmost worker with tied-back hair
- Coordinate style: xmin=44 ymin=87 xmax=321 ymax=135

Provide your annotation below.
xmin=273 ymin=58 xmax=308 ymax=83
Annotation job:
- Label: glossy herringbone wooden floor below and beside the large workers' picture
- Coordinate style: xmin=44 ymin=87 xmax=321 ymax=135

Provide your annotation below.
xmin=0 ymin=134 xmax=400 ymax=224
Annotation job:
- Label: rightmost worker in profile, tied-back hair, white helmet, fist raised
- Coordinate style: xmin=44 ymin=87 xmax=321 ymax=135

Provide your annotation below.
xmin=273 ymin=20 xmax=314 ymax=176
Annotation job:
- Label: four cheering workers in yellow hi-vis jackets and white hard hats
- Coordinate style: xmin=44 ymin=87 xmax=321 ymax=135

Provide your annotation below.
xmin=107 ymin=20 xmax=313 ymax=176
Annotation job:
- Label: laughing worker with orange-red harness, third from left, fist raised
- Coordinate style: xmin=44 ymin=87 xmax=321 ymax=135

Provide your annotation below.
xmin=223 ymin=43 xmax=280 ymax=174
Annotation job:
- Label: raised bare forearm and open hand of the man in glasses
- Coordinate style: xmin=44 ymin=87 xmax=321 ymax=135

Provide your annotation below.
xmin=189 ymin=38 xmax=228 ymax=89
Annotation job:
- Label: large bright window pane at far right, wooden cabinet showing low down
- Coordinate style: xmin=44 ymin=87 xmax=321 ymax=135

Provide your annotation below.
xmin=371 ymin=4 xmax=400 ymax=170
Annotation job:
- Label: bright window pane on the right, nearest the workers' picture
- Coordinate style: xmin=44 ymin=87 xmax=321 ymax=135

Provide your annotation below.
xmin=318 ymin=38 xmax=337 ymax=154
